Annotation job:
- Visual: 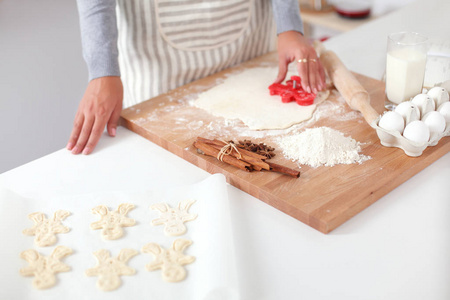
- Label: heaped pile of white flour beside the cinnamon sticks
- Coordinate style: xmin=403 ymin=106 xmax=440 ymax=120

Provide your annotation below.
xmin=277 ymin=127 xmax=370 ymax=168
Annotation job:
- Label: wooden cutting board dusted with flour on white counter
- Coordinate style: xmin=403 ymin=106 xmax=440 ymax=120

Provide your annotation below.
xmin=121 ymin=53 xmax=450 ymax=233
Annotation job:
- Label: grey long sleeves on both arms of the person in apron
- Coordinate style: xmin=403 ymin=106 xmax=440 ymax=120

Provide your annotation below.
xmin=77 ymin=0 xmax=303 ymax=80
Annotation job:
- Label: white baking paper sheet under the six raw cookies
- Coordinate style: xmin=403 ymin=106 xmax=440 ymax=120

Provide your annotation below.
xmin=0 ymin=174 xmax=238 ymax=300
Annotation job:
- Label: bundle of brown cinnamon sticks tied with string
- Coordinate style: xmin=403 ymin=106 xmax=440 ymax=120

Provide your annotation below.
xmin=194 ymin=137 xmax=300 ymax=178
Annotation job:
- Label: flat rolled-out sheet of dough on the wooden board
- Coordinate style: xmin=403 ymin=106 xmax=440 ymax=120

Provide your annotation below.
xmin=194 ymin=68 xmax=330 ymax=130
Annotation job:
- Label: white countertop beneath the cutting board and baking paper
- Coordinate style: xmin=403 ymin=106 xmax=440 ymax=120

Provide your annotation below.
xmin=0 ymin=0 xmax=450 ymax=300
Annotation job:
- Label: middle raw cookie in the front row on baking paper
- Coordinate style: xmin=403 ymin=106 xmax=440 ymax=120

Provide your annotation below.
xmin=86 ymin=249 xmax=139 ymax=292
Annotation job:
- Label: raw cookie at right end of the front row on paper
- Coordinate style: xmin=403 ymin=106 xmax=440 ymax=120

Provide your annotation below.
xmin=141 ymin=239 xmax=195 ymax=282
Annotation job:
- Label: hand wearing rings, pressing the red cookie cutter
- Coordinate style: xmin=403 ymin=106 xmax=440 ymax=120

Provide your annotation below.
xmin=275 ymin=31 xmax=325 ymax=93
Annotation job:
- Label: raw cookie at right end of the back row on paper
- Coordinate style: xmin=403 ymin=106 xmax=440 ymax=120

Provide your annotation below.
xmin=150 ymin=200 xmax=197 ymax=236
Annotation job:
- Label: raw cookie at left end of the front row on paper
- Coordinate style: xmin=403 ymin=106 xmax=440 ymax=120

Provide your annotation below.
xmin=19 ymin=246 xmax=72 ymax=290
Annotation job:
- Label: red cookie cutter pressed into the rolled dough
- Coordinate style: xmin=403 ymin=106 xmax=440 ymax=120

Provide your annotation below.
xmin=269 ymin=76 xmax=316 ymax=106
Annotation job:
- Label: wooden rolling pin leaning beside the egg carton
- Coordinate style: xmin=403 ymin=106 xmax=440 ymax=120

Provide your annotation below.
xmin=314 ymin=41 xmax=379 ymax=125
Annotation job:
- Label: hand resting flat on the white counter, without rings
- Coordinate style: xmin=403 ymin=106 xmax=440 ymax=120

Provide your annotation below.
xmin=66 ymin=76 xmax=123 ymax=154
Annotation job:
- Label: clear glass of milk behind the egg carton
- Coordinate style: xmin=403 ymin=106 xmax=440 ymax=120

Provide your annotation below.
xmin=386 ymin=32 xmax=428 ymax=104
